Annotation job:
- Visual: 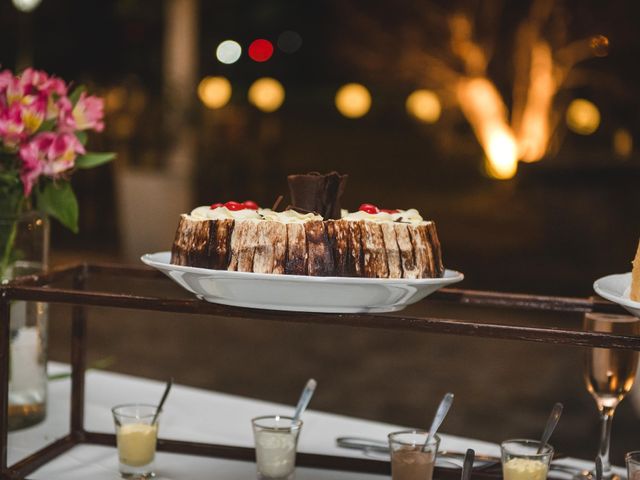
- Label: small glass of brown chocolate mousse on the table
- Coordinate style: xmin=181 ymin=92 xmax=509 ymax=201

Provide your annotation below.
xmin=389 ymin=430 xmax=440 ymax=480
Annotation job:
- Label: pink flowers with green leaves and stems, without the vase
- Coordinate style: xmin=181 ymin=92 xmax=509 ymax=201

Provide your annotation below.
xmin=0 ymin=68 xmax=114 ymax=280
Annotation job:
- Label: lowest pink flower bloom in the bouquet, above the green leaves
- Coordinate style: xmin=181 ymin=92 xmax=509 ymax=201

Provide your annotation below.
xmin=19 ymin=132 xmax=85 ymax=196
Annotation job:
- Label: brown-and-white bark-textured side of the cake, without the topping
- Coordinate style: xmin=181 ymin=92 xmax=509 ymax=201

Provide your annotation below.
xmin=171 ymin=215 xmax=444 ymax=278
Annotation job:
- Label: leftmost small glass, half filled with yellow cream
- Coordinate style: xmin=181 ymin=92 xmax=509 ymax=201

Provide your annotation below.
xmin=111 ymin=403 xmax=159 ymax=479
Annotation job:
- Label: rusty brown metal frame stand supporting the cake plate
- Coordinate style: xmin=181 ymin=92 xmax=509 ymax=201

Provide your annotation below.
xmin=0 ymin=263 xmax=640 ymax=480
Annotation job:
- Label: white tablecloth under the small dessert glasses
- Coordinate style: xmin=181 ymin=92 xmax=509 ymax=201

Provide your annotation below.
xmin=8 ymin=364 xmax=622 ymax=480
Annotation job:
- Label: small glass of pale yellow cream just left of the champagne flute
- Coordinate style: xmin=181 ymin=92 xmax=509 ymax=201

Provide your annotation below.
xmin=500 ymin=439 xmax=553 ymax=480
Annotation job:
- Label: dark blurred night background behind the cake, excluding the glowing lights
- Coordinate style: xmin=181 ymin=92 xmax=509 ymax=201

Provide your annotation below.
xmin=0 ymin=0 xmax=640 ymax=463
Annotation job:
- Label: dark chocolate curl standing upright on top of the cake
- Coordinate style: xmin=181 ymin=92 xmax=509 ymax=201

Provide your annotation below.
xmin=287 ymin=172 xmax=348 ymax=220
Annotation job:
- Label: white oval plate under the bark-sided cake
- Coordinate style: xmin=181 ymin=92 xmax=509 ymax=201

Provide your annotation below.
xmin=141 ymin=252 xmax=464 ymax=313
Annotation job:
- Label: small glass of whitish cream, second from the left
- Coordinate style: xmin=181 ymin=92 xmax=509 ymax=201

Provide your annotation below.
xmin=251 ymin=415 xmax=302 ymax=480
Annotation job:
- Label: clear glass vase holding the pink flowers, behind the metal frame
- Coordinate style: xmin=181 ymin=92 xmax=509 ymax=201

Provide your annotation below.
xmin=0 ymin=210 xmax=49 ymax=430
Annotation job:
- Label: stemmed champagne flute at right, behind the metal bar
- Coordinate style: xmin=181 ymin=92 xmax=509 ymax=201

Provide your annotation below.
xmin=584 ymin=313 xmax=640 ymax=480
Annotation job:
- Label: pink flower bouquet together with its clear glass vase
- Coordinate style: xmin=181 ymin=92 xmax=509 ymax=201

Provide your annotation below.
xmin=0 ymin=68 xmax=114 ymax=430
